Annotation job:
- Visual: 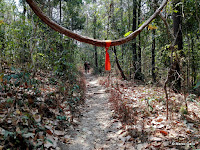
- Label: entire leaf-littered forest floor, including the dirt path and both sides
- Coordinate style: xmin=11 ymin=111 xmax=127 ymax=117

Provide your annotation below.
xmin=0 ymin=69 xmax=200 ymax=150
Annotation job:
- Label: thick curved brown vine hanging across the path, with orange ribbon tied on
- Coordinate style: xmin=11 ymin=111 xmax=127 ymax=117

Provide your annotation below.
xmin=26 ymin=0 xmax=168 ymax=47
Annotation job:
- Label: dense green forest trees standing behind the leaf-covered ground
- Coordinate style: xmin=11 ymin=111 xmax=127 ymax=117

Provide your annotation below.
xmin=1 ymin=0 xmax=200 ymax=91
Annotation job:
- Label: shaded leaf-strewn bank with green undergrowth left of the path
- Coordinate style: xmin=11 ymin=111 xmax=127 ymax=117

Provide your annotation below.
xmin=0 ymin=64 xmax=86 ymax=150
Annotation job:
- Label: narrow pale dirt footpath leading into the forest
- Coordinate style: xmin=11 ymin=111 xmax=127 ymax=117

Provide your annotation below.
xmin=65 ymin=74 xmax=133 ymax=150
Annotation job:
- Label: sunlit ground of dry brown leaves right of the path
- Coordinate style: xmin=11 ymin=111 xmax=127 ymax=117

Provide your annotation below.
xmin=99 ymin=77 xmax=200 ymax=149
